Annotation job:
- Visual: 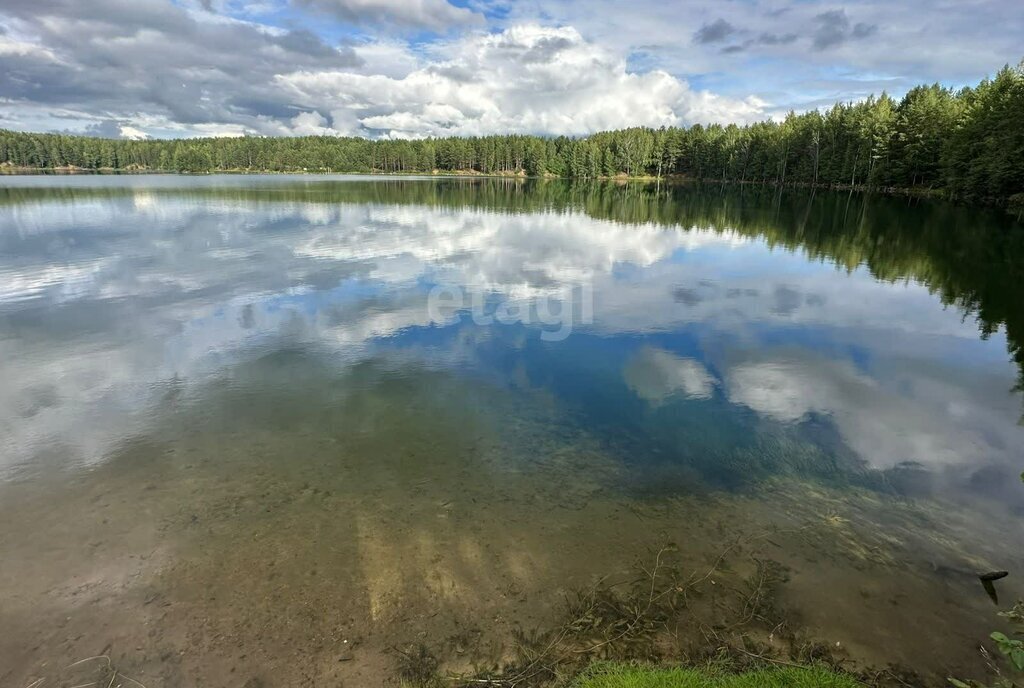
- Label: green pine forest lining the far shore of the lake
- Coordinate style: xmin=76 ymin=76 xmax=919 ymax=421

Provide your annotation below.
xmin=0 ymin=61 xmax=1024 ymax=204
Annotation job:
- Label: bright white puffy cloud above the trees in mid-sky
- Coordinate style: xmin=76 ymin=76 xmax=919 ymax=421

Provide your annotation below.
xmin=276 ymin=25 xmax=765 ymax=137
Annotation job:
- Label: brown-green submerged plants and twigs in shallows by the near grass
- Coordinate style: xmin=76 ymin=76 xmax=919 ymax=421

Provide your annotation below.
xmin=391 ymin=540 xmax=880 ymax=688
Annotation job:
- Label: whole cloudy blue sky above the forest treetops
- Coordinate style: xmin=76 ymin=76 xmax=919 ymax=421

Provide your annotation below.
xmin=0 ymin=0 xmax=1024 ymax=138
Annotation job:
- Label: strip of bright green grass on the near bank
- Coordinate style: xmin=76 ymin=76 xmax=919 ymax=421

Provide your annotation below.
xmin=571 ymin=664 xmax=862 ymax=688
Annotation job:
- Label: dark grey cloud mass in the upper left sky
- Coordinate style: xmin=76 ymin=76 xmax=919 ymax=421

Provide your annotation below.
xmin=0 ymin=0 xmax=360 ymax=135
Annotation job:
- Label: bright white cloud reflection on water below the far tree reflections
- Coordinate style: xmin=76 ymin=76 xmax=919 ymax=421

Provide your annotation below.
xmin=290 ymin=201 xmax=734 ymax=296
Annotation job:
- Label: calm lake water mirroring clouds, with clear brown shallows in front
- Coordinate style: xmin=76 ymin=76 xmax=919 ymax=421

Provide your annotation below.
xmin=0 ymin=176 xmax=1024 ymax=688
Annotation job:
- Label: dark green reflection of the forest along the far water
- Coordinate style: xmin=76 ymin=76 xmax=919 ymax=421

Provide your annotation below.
xmin=6 ymin=177 xmax=1024 ymax=403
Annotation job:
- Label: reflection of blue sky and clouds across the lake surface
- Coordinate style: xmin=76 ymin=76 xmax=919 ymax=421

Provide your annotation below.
xmin=0 ymin=178 xmax=1024 ymax=502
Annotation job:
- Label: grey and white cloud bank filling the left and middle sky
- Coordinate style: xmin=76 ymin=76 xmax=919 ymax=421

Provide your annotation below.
xmin=0 ymin=0 xmax=764 ymax=137
